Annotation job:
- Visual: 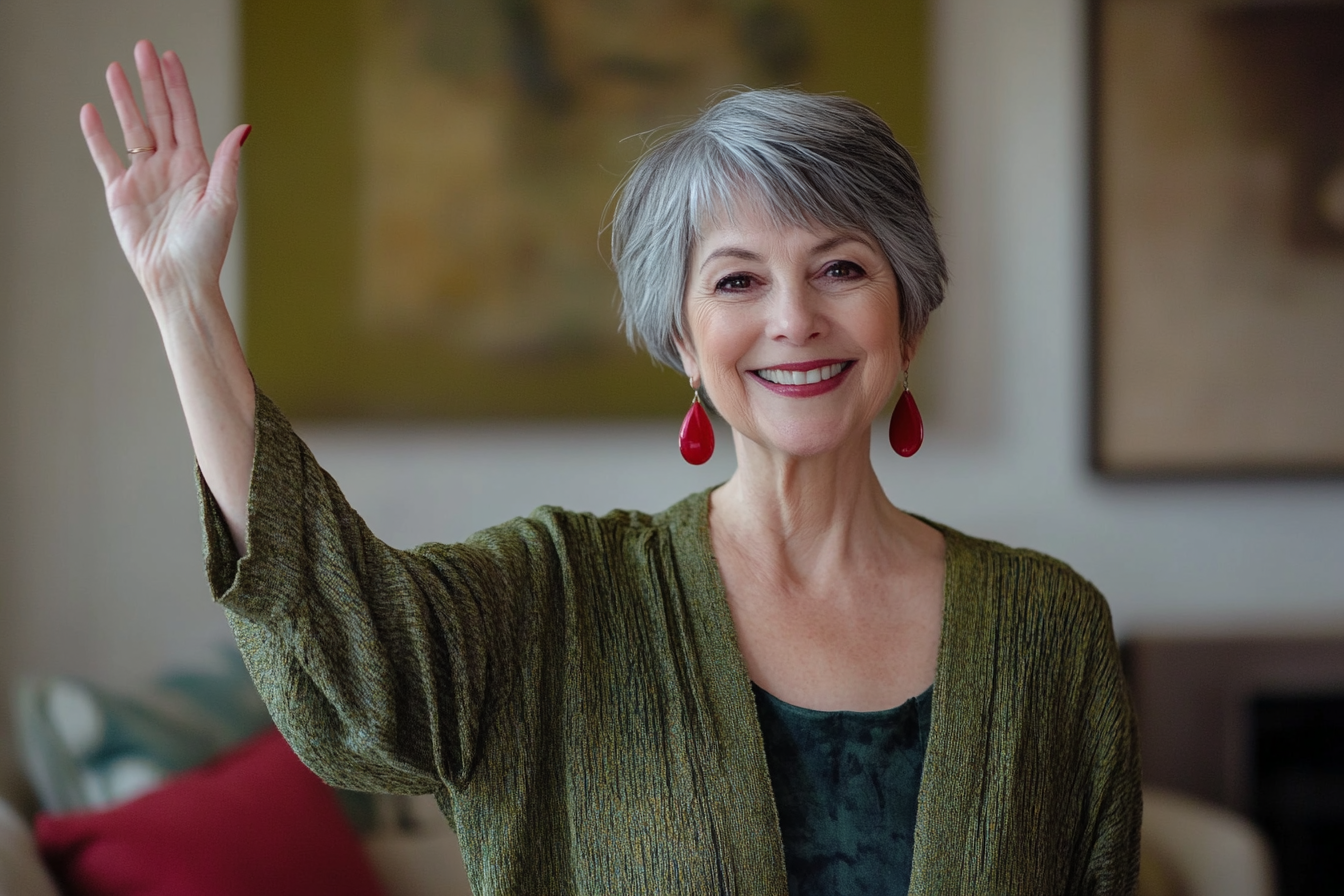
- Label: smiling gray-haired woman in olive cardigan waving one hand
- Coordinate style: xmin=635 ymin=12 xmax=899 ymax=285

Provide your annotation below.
xmin=82 ymin=42 xmax=1140 ymax=895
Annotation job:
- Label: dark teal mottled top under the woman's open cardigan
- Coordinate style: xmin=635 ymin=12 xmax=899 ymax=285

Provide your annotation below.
xmin=751 ymin=684 xmax=933 ymax=896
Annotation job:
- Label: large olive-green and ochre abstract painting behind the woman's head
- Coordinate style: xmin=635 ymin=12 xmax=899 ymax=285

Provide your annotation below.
xmin=242 ymin=0 xmax=929 ymax=419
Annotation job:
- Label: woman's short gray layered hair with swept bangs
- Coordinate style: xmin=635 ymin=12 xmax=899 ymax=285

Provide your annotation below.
xmin=612 ymin=90 xmax=948 ymax=369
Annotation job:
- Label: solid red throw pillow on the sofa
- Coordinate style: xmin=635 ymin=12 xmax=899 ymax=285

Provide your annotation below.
xmin=36 ymin=729 xmax=382 ymax=896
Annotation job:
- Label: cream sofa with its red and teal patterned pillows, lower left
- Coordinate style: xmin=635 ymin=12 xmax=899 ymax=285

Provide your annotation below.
xmin=0 ymin=647 xmax=470 ymax=896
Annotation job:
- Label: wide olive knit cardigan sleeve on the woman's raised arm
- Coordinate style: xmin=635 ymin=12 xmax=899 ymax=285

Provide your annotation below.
xmin=198 ymin=391 xmax=562 ymax=793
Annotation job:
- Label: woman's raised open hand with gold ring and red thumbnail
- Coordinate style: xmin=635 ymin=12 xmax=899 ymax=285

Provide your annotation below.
xmin=79 ymin=40 xmax=251 ymax=308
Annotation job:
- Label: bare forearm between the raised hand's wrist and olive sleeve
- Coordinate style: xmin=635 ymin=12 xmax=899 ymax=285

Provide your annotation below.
xmin=151 ymin=283 xmax=257 ymax=555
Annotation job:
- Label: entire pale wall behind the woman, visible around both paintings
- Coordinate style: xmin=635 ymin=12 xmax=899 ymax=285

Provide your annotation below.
xmin=0 ymin=0 xmax=1344 ymax=795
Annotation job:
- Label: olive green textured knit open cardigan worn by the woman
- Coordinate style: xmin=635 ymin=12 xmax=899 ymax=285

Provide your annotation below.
xmin=202 ymin=394 xmax=1140 ymax=896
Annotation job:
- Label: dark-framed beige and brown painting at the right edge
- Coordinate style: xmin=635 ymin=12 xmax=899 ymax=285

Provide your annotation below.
xmin=1091 ymin=0 xmax=1344 ymax=477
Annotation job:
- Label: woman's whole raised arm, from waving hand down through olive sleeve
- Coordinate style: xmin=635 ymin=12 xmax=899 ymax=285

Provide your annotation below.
xmin=81 ymin=42 xmax=554 ymax=791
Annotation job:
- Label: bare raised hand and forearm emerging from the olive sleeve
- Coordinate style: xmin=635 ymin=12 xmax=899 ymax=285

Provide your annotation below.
xmin=79 ymin=40 xmax=255 ymax=551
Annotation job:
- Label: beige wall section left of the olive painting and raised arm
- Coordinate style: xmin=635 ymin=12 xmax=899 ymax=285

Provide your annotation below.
xmin=0 ymin=0 xmax=238 ymax=789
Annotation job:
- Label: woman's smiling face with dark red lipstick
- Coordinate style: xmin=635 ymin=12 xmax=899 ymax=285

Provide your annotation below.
xmin=679 ymin=204 xmax=905 ymax=457
